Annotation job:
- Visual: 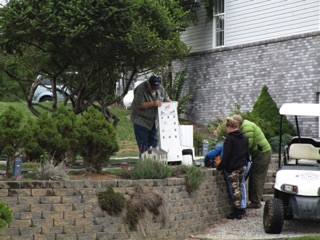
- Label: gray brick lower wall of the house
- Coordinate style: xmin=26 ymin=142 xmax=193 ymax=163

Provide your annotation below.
xmin=174 ymin=31 xmax=320 ymax=137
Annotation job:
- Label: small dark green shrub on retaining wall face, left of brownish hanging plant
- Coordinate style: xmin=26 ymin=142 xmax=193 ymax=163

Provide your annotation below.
xmin=97 ymin=187 xmax=126 ymax=216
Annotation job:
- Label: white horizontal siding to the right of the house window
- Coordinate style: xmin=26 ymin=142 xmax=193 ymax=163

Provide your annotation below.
xmin=225 ymin=0 xmax=320 ymax=46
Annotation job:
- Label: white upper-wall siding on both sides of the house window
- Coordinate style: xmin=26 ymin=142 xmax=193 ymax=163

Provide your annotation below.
xmin=181 ymin=0 xmax=320 ymax=52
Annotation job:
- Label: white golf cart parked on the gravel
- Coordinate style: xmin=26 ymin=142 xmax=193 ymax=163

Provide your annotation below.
xmin=263 ymin=103 xmax=320 ymax=233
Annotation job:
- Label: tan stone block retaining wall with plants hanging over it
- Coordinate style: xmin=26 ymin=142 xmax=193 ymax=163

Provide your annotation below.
xmin=0 ymin=170 xmax=231 ymax=240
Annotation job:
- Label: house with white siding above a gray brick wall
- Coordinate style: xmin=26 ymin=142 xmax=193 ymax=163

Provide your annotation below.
xmin=173 ymin=0 xmax=320 ymax=137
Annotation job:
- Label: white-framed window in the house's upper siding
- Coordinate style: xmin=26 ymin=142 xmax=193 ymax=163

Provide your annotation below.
xmin=214 ymin=0 xmax=224 ymax=47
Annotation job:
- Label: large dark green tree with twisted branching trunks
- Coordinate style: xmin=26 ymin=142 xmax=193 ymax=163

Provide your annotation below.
xmin=0 ymin=0 xmax=189 ymax=124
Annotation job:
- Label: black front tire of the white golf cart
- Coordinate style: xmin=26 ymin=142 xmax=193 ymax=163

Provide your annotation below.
xmin=263 ymin=198 xmax=284 ymax=233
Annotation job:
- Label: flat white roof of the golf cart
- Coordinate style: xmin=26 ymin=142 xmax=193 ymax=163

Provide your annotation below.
xmin=279 ymin=103 xmax=320 ymax=116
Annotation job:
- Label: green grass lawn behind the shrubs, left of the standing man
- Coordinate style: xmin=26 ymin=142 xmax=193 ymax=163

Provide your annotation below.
xmin=0 ymin=102 xmax=139 ymax=157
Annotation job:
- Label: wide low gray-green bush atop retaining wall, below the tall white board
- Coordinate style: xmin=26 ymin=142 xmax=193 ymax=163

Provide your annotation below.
xmin=130 ymin=159 xmax=172 ymax=179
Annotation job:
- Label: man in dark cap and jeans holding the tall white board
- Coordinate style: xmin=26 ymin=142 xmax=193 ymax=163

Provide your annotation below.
xmin=131 ymin=76 xmax=171 ymax=157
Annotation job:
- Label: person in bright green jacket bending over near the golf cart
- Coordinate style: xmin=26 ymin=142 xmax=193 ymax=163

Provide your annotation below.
xmin=233 ymin=115 xmax=271 ymax=208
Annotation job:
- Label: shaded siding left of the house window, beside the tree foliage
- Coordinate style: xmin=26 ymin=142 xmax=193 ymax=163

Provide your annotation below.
xmin=181 ymin=5 xmax=213 ymax=52
